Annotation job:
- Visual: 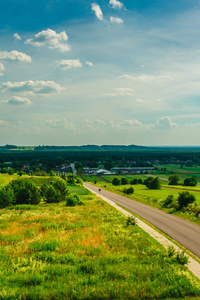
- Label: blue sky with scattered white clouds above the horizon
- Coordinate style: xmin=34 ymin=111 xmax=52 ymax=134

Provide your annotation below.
xmin=0 ymin=0 xmax=200 ymax=146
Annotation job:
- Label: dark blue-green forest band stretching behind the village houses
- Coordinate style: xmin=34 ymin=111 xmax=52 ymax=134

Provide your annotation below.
xmin=0 ymin=149 xmax=200 ymax=168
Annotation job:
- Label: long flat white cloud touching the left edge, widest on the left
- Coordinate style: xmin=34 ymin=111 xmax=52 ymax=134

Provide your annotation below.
xmin=0 ymin=80 xmax=63 ymax=95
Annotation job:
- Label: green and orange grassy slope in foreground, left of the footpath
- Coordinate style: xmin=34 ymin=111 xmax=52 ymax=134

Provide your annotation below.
xmin=0 ymin=187 xmax=200 ymax=300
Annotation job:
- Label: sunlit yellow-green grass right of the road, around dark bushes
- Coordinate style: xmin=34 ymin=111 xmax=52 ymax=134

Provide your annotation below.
xmin=86 ymin=176 xmax=200 ymax=225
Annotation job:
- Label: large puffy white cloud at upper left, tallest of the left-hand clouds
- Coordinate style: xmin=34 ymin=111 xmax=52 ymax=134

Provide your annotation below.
xmin=25 ymin=29 xmax=70 ymax=52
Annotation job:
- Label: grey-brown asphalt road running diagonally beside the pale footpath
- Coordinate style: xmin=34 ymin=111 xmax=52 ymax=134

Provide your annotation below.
xmin=84 ymin=183 xmax=200 ymax=258
